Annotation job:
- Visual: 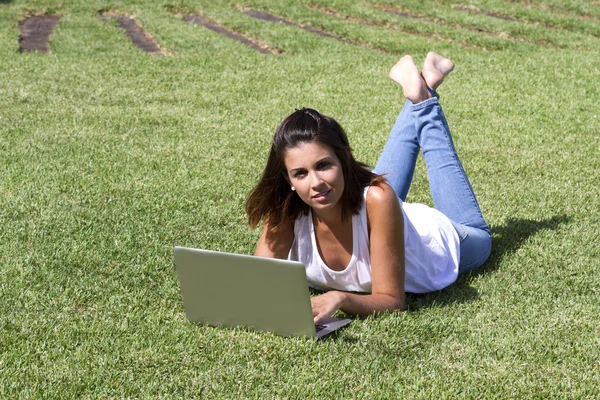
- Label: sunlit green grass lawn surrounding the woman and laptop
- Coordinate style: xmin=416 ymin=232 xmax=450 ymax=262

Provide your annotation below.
xmin=0 ymin=0 xmax=600 ymax=399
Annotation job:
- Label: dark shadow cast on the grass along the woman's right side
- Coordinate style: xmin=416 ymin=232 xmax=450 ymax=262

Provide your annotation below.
xmin=406 ymin=215 xmax=570 ymax=311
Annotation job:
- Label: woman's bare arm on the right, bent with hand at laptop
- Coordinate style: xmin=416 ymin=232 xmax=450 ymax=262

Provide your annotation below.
xmin=312 ymin=184 xmax=404 ymax=322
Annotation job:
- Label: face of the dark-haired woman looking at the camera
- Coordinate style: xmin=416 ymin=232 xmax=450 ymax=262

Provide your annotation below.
xmin=283 ymin=142 xmax=344 ymax=211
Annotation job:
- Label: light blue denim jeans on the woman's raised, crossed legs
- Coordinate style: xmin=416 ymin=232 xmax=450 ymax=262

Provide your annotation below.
xmin=375 ymin=89 xmax=492 ymax=274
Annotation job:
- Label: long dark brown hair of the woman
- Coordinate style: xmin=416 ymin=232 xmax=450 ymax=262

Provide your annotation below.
xmin=246 ymin=108 xmax=384 ymax=230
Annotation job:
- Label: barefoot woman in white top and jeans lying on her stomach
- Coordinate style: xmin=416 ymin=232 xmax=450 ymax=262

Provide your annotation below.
xmin=246 ymin=53 xmax=491 ymax=322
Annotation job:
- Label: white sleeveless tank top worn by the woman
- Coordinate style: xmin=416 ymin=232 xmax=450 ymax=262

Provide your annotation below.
xmin=288 ymin=187 xmax=460 ymax=293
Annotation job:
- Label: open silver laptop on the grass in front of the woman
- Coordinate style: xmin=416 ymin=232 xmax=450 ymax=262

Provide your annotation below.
xmin=174 ymin=247 xmax=352 ymax=338
